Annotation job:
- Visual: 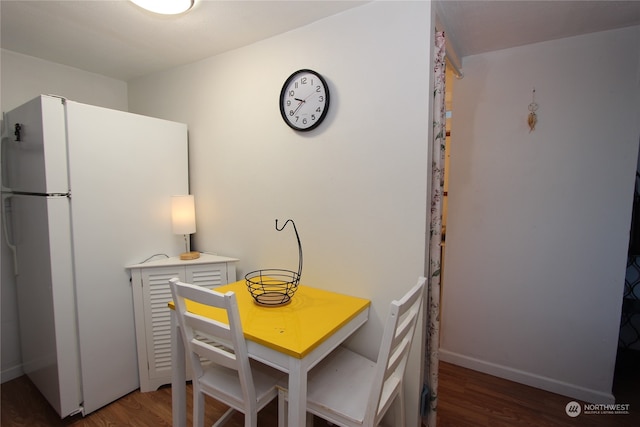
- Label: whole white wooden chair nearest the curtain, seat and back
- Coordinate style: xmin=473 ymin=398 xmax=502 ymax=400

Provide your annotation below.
xmin=278 ymin=277 xmax=426 ymax=427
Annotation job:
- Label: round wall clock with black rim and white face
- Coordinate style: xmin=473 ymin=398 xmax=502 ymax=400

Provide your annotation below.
xmin=280 ymin=70 xmax=329 ymax=132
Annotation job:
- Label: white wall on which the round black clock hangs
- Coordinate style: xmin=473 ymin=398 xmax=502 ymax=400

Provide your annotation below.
xmin=129 ymin=2 xmax=433 ymax=425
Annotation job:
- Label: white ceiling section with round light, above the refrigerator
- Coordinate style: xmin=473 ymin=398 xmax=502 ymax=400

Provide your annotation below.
xmin=0 ymin=0 xmax=363 ymax=81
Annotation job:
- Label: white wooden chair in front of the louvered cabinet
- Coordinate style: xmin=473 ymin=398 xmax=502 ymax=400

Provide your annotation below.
xmin=169 ymin=278 xmax=286 ymax=427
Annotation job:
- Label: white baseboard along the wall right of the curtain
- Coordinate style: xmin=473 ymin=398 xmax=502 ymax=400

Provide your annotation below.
xmin=439 ymin=349 xmax=615 ymax=403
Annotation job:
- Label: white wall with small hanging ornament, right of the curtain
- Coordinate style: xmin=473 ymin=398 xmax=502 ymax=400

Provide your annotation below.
xmin=441 ymin=27 xmax=640 ymax=403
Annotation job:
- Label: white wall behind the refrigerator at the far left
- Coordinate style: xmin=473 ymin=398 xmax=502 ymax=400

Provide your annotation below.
xmin=0 ymin=49 xmax=127 ymax=382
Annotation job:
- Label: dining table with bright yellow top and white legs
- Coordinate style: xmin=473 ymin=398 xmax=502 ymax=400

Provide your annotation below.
xmin=169 ymin=280 xmax=370 ymax=427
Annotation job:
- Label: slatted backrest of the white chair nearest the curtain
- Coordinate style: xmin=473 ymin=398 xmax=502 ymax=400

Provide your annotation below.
xmin=364 ymin=277 xmax=426 ymax=425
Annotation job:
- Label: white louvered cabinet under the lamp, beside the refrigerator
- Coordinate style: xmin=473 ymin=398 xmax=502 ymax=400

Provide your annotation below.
xmin=127 ymin=253 xmax=238 ymax=392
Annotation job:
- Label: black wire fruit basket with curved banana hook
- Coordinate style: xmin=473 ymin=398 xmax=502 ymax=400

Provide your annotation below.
xmin=244 ymin=219 xmax=302 ymax=307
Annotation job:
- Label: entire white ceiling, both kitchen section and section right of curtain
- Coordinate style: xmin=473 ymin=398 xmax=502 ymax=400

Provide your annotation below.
xmin=0 ymin=0 xmax=640 ymax=81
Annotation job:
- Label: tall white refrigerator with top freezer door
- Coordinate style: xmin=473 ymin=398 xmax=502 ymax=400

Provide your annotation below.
xmin=1 ymin=96 xmax=188 ymax=418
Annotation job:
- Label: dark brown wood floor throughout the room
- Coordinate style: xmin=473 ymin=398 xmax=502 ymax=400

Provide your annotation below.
xmin=0 ymin=362 xmax=640 ymax=427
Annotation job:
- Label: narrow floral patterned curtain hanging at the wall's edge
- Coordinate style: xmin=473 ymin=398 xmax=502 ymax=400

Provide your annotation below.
xmin=423 ymin=32 xmax=446 ymax=427
